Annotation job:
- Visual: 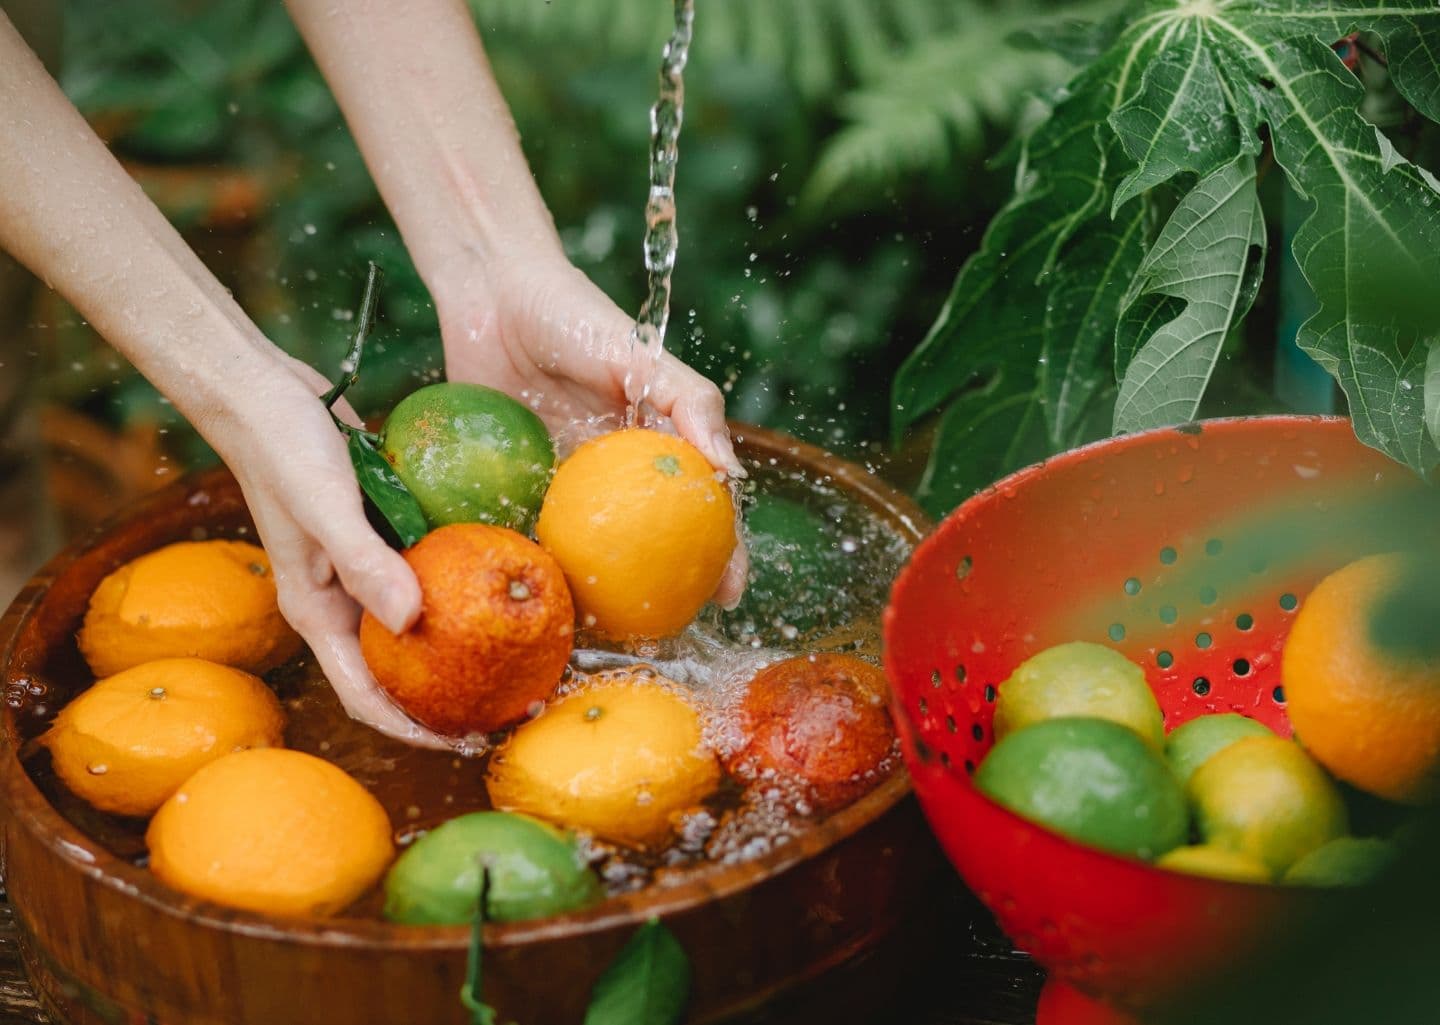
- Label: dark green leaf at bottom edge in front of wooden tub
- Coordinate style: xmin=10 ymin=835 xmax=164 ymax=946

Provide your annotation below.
xmin=585 ymin=918 xmax=690 ymax=1025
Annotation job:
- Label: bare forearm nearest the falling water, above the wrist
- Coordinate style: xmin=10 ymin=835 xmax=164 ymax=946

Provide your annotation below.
xmin=287 ymin=0 xmax=560 ymax=294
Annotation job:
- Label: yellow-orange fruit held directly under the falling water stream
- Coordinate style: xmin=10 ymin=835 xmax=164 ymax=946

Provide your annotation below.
xmin=536 ymin=429 xmax=736 ymax=638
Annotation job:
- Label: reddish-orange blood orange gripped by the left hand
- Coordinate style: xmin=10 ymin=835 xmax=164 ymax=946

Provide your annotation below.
xmin=360 ymin=523 xmax=575 ymax=737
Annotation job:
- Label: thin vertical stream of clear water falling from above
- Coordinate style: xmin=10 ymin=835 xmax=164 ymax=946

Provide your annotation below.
xmin=625 ymin=0 xmax=696 ymax=426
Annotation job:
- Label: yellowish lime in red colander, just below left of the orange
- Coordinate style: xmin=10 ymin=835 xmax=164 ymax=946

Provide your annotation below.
xmin=1187 ymin=736 xmax=1349 ymax=875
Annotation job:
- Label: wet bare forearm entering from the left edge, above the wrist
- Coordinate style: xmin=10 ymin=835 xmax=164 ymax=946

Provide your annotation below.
xmin=0 ymin=14 xmax=278 ymax=443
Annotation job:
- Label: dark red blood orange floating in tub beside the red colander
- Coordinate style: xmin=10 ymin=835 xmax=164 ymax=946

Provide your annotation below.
xmin=726 ymin=655 xmax=896 ymax=808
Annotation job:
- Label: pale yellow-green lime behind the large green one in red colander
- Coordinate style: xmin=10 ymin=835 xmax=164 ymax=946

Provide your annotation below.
xmin=995 ymin=641 xmax=1165 ymax=750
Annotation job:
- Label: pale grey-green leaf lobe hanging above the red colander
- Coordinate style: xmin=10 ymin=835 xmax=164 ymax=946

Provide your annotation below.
xmin=1115 ymin=157 xmax=1266 ymax=432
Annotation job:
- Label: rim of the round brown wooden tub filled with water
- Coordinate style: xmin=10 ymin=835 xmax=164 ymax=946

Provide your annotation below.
xmin=0 ymin=422 xmax=933 ymax=952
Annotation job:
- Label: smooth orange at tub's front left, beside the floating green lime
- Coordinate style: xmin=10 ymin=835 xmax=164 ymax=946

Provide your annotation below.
xmin=145 ymin=747 xmax=395 ymax=916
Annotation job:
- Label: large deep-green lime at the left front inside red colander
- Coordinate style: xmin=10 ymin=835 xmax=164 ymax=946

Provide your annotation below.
xmin=975 ymin=718 xmax=1189 ymax=858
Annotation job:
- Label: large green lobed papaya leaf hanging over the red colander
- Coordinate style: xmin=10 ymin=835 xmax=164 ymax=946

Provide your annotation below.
xmin=893 ymin=0 xmax=1440 ymax=511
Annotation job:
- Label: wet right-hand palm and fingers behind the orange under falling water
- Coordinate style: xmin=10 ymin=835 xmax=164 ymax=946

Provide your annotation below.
xmin=432 ymin=255 xmax=749 ymax=608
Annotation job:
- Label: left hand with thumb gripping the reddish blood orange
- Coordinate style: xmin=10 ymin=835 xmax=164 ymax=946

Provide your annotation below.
xmin=214 ymin=351 xmax=448 ymax=747
